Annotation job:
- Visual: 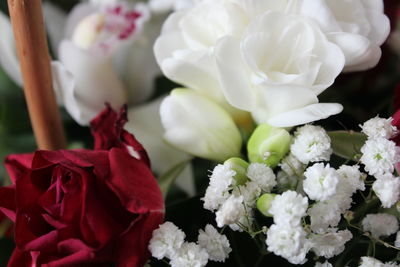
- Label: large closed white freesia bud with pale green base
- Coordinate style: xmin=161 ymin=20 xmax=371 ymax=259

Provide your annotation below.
xmin=160 ymin=89 xmax=242 ymax=162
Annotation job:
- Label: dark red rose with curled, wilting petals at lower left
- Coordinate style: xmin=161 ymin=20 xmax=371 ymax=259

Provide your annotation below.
xmin=0 ymin=108 xmax=164 ymax=267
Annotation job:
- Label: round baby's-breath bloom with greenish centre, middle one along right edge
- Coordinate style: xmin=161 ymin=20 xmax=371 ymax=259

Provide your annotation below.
xmin=360 ymin=138 xmax=398 ymax=176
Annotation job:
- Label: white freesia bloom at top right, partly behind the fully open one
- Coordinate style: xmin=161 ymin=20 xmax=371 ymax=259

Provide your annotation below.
xmin=296 ymin=0 xmax=390 ymax=71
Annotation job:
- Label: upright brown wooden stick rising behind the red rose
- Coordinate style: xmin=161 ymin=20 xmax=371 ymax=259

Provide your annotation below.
xmin=8 ymin=0 xmax=66 ymax=150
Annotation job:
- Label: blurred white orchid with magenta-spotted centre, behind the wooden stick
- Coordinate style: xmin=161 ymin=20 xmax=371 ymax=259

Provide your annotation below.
xmin=0 ymin=1 xmax=194 ymax=195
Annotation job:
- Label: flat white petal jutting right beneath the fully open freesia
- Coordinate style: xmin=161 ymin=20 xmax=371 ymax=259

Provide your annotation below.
xmin=268 ymin=103 xmax=343 ymax=127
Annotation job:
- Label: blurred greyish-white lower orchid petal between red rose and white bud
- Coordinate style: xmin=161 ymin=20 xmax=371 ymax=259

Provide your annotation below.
xmin=125 ymin=97 xmax=195 ymax=196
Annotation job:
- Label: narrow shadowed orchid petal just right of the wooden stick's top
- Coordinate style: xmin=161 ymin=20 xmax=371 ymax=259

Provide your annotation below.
xmin=43 ymin=2 xmax=67 ymax=57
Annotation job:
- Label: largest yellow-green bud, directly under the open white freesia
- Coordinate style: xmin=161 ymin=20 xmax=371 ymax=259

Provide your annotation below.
xmin=247 ymin=124 xmax=292 ymax=168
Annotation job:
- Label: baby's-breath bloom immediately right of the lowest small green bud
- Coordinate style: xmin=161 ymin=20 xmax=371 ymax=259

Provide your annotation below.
xmin=268 ymin=190 xmax=308 ymax=226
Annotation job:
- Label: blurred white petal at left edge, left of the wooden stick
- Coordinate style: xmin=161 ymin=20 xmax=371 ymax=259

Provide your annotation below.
xmin=0 ymin=11 xmax=22 ymax=86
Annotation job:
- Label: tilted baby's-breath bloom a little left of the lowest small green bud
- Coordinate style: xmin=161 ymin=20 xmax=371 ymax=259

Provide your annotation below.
xmin=215 ymin=196 xmax=245 ymax=227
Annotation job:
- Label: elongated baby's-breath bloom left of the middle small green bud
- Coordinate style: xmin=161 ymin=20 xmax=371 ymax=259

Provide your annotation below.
xmin=202 ymin=164 xmax=236 ymax=211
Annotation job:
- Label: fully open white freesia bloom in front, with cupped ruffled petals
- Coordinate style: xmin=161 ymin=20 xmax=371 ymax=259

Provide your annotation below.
xmin=215 ymin=12 xmax=344 ymax=127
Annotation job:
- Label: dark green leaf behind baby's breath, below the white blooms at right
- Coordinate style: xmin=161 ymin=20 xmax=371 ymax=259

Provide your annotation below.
xmin=328 ymin=131 xmax=367 ymax=161
